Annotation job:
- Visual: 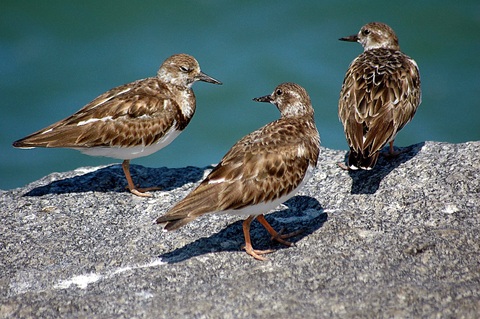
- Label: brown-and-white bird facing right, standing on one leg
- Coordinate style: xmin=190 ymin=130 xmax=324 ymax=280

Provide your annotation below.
xmin=13 ymin=53 xmax=222 ymax=197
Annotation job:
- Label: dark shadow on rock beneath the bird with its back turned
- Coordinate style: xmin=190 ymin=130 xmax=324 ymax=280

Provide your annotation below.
xmin=345 ymin=142 xmax=425 ymax=194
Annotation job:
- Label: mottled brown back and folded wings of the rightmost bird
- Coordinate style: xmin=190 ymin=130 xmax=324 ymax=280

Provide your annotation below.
xmin=339 ymin=50 xmax=421 ymax=155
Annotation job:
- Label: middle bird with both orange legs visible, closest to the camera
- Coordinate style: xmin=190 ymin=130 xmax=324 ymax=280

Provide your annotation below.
xmin=156 ymin=83 xmax=320 ymax=260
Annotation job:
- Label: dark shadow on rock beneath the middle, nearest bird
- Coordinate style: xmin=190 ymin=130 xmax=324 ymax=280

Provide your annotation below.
xmin=159 ymin=196 xmax=328 ymax=264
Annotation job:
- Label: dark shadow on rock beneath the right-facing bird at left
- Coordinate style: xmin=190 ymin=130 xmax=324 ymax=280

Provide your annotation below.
xmin=23 ymin=164 xmax=209 ymax=196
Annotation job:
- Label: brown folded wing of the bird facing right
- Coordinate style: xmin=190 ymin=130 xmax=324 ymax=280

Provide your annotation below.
xmin=14 ymin=78 xmax=185 ymax=148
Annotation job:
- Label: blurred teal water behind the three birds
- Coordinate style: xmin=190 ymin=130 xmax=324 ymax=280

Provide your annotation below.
xmin=0 ymin=0 xmax=480 ymax=189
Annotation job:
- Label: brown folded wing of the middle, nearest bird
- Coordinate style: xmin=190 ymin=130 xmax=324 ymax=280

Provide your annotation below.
xmin=157 ymin=120 xmax=319 ymax=230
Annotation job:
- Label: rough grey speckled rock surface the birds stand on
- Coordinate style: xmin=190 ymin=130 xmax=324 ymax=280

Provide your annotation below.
xmin=0 ymin=142 xmax=480 ymax=318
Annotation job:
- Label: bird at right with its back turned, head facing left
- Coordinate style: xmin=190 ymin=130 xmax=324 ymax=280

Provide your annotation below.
xmin=338 ymin=22 xmax=422 ymax=170
